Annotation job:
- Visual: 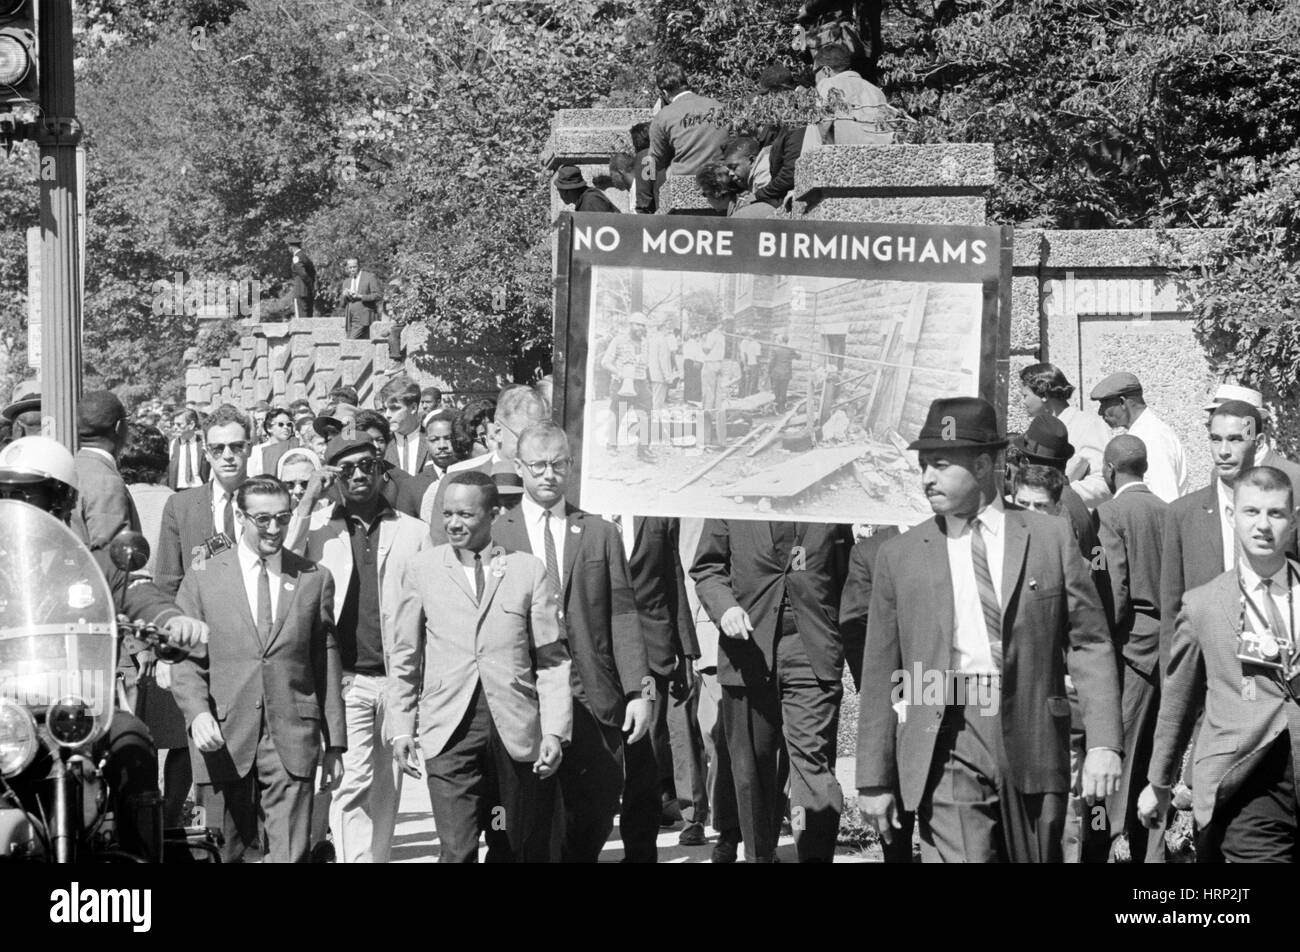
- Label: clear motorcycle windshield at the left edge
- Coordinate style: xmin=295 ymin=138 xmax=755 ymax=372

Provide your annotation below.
xmin=0 ymin=499 xmax=117 ymax=743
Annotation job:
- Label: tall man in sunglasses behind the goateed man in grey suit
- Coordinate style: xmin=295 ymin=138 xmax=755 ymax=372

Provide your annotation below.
xmin=155 ymin=403 xmax=252 ymax=596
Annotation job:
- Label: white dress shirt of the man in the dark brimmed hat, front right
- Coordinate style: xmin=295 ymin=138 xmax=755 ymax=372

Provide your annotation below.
xmin=946 ymin=499 xmax=1006 ymax=674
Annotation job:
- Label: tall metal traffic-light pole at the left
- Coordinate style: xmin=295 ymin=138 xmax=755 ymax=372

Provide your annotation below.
xmin=36 ymin=0 xmax=82 ymax=451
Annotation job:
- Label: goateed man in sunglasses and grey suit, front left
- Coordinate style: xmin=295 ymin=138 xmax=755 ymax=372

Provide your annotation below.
xmin=172 ymin=476 xmax=347 ymax=862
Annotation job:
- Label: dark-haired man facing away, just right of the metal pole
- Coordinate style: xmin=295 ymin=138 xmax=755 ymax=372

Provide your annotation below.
xmin=73 ymin=390 xmax=140 ymax=553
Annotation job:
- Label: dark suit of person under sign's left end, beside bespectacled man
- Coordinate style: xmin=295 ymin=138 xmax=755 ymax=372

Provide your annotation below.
xmin=621 ymin=516 xmax=709 ymax=861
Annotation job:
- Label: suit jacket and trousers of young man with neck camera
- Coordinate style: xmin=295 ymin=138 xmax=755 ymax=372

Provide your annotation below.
xmin=1148 ymin=563 xmax=1300 ymax=862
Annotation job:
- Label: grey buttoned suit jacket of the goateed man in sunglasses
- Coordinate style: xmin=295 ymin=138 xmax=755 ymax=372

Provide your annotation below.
xmin=172 ymin=549 xmax=347 ymax=783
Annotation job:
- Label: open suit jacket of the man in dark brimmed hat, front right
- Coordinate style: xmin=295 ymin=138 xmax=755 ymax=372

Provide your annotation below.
xmin=857 ymin=509 xmax=1123 ymax=810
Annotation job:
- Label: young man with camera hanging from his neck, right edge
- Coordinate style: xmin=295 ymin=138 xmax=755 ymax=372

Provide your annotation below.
xmin=1139 ymin=467 xmax=1300 ymax=862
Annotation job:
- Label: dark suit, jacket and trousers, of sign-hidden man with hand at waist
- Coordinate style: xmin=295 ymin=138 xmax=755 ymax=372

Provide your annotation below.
xmin=690 ymin=519 xmax=852 ymax=862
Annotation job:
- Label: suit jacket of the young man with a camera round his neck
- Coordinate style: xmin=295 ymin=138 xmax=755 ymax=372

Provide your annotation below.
xmin=1147 ymin=570 xmax=1288 ymax=827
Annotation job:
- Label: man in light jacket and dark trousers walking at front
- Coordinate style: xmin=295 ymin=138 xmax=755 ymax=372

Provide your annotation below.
xmin=389 ymin=472 xmax=573 ymax=862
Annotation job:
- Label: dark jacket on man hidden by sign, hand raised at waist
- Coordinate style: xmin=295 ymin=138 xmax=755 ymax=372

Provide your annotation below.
xmin=690 ymin=519 xmax=853 ymax=687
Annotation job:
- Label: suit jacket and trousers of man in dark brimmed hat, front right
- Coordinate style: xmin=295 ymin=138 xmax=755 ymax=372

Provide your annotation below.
xmin=857 ymin=510 xmax=1123 ymax=862
